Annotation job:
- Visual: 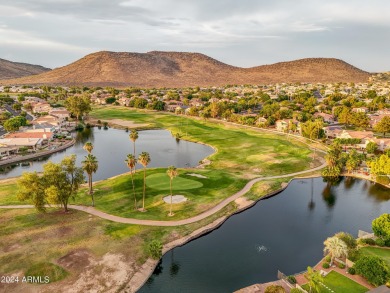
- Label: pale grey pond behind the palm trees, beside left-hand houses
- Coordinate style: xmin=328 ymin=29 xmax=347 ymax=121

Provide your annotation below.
xmin=0 ymin=128 xmax=214 ymax=181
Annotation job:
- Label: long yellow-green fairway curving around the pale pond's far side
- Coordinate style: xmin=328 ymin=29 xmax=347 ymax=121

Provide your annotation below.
xmin=90 ymin=106 xmax=320 ymax=178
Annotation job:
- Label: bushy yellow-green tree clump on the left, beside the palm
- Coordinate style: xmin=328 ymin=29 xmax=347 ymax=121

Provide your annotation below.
xmin=18 ymin=155 xmax=84 ymax=212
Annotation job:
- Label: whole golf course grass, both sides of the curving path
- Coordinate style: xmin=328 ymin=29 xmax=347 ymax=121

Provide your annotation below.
xmin=0 ymin=106 xmax=322 ymax=288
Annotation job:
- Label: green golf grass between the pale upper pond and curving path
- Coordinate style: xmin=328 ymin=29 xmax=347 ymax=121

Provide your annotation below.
xmin=0 ymin=106 xmax=319 ymax=220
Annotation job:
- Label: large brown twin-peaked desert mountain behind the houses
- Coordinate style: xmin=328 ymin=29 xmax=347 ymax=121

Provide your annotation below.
xmin=0 ymin=51 xmax=370 ymax=87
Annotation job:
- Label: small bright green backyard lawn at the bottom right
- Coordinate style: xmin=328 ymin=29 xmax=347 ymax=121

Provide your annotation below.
xmin=302 ymin=271 xmax=368 ymax=293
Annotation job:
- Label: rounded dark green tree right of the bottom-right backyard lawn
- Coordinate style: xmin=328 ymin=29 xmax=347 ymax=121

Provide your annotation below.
xmin=354 ymin=255 xmax=390 ymax=286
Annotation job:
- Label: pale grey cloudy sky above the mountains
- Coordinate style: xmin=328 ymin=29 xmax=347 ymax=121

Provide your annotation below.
xmin=0 ymin=0 xmax=390 ymax=72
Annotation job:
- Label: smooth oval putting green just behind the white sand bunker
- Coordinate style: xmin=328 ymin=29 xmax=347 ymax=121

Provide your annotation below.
xmin=146 ymin=173 xmax=203 ymax=191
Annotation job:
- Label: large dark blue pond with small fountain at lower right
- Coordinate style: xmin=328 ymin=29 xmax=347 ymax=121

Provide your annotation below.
xmin=139 ymin=178 xmax=390 ymax=293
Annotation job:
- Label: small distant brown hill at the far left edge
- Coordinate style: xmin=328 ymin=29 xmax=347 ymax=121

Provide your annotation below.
xmin=0 ymin=59 xmax=51 ymax=79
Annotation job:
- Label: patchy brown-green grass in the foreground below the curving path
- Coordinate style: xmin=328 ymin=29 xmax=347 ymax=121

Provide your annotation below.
xmin=0 ymin=204 xmax=235 ymax=292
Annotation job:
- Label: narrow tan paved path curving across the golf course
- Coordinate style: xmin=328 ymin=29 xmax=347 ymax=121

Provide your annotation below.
xmin=0 ymin=163 xmax=326 ymax=227
